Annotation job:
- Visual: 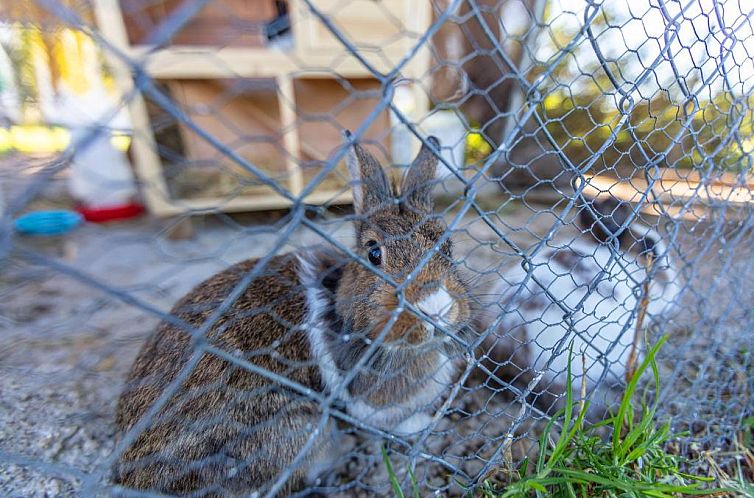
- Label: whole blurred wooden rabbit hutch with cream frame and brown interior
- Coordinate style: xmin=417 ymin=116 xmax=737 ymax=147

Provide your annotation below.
xmin=89 ymin=0 xmax=431 ymax=216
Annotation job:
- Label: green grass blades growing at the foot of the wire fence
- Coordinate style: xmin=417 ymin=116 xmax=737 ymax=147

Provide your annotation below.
xmin=382 ymin=337 xmax=740 ymax=498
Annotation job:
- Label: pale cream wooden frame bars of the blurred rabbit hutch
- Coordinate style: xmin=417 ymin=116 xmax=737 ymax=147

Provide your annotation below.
xmin=94 ymin=0 xmax=431 ymax=216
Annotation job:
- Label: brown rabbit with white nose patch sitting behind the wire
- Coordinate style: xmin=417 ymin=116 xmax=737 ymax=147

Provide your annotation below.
xmin=114 ymin=132 xmax=470 ymax=496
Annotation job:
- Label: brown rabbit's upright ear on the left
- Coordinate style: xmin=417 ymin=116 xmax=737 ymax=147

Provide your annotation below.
xmin=343 ymin=130 xmax=393 ymax=214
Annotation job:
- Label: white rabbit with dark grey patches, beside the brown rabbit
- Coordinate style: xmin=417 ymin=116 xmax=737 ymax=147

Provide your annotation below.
xmin=482 ymin=198 xmax=682 ymax=409
